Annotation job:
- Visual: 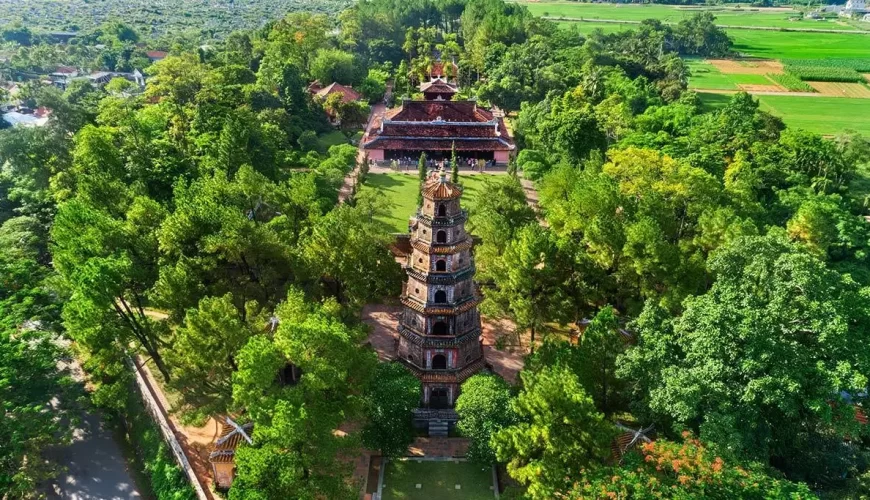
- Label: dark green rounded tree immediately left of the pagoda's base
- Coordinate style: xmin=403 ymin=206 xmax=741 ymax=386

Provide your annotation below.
xmin=362 ymin=363 xmax=420 ymax=457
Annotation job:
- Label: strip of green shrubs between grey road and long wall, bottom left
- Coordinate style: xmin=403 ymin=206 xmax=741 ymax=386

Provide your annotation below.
xmin=123 ymin=388 xmax=196 ymax=500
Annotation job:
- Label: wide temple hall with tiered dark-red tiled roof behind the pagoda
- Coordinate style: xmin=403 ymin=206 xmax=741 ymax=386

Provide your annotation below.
xmin=362 ymin=78 xmax=516 ymax=165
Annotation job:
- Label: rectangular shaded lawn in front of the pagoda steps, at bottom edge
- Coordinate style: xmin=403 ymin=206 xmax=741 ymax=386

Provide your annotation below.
xmin=383 ymin=459 xmax=495 ymax=500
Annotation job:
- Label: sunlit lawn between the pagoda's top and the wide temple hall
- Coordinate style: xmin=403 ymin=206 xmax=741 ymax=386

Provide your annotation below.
xmin=363 ymin=171 xmax=494 ymax=233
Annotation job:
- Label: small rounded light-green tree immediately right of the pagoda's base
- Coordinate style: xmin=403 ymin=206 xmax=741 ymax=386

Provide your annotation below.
xmin=456 ymin=374 xmax=517 ymax=464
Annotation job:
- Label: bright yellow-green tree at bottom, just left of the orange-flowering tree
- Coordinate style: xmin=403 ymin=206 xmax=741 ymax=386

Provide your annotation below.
xmin=492 ymin=368 xmax=614 ymax=500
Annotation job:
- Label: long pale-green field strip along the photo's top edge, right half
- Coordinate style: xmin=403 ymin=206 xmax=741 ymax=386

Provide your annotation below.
xmin=521 ymin=2 xmax=856 ymax=31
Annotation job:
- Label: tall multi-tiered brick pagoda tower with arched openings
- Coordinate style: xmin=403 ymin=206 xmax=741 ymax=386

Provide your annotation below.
xmin=398 ymin=171 xmax=484 ymax=409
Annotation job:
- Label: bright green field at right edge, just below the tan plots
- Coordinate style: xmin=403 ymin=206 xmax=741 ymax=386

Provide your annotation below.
xmin=698 ymin=93 xmax=870 ymax=135
